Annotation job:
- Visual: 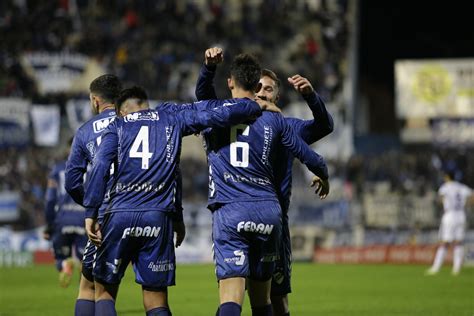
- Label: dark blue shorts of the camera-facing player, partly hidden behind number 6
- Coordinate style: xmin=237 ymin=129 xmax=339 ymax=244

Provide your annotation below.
xmin=271 ymin=211 xmax=292 ymax=296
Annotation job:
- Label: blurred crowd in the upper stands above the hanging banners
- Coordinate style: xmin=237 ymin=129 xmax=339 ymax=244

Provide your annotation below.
xmin=0 ymin=0 xmax=348 ymax=101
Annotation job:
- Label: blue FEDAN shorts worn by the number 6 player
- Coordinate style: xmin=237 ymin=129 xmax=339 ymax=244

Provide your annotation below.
xmin=212 ymin=201 xmax=281 ymax=281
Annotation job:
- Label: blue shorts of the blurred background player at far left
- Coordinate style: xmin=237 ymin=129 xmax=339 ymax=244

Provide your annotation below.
xmin=52 ymin=225 xmax=87 ymax=271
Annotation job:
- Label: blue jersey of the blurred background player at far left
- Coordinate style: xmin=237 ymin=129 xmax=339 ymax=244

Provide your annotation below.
xmin=46 ymin=161 xmax=85 ymax=227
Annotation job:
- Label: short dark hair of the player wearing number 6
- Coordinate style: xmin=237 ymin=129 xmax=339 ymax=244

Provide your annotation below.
xmin=230 ymin=54 xmax=262 ymax=91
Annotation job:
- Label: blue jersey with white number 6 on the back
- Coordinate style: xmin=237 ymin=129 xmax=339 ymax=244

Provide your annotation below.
xmin=204 ymin=112 xmax=328 ymax=209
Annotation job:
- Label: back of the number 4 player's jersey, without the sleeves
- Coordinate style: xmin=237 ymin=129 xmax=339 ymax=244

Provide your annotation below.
xmin=105 ymin=110 xmax=182 ymax=211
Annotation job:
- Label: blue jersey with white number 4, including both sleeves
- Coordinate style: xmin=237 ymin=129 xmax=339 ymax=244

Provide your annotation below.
xmin=85 ymin=99 xmax=261 ymax=217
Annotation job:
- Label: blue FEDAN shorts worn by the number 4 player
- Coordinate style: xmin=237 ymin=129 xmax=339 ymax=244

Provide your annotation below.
xmin=94 ymin=211 xmax=176 ymax=289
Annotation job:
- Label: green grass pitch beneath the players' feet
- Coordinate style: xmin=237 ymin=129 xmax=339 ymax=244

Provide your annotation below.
xmin=0 ymin=264 xmax=474 ymax=316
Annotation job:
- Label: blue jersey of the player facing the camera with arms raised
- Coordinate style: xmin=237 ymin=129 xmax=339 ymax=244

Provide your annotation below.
xmin=196 ymin=65 xmax=334 ymax=212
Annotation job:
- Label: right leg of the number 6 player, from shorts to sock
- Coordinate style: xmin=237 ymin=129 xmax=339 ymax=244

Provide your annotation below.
xmin=244 ymin=202 xmax=281 ymax=316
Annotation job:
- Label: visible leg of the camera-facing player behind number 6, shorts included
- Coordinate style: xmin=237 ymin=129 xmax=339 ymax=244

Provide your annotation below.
xmin=271 ymin=210 xmax=292 ymax=316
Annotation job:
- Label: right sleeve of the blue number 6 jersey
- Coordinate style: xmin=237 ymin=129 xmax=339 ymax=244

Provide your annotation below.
xmin=276 ymin=115 xmax=329 ymax=180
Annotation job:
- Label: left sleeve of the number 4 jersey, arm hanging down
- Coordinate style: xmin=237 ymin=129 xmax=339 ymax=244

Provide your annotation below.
xmin=84 ymin=120 xmax=118 ymax=218
